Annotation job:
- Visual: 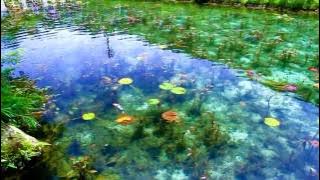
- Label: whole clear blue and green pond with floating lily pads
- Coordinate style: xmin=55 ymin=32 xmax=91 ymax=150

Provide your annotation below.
xmin=1 ymin=1 xmax=319 ymax=180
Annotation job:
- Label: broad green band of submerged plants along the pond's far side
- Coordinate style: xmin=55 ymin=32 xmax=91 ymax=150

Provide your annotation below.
xmin=1 ymin=1 xmax=319 ymax=104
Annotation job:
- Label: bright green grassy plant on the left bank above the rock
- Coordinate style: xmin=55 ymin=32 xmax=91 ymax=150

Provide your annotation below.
xmin=1 ymin=53 xmax=49 ymax=131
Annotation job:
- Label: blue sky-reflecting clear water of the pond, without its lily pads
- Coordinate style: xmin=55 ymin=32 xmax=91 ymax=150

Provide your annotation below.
xmin=1 ymin=1 xmax=319 ymax=180
